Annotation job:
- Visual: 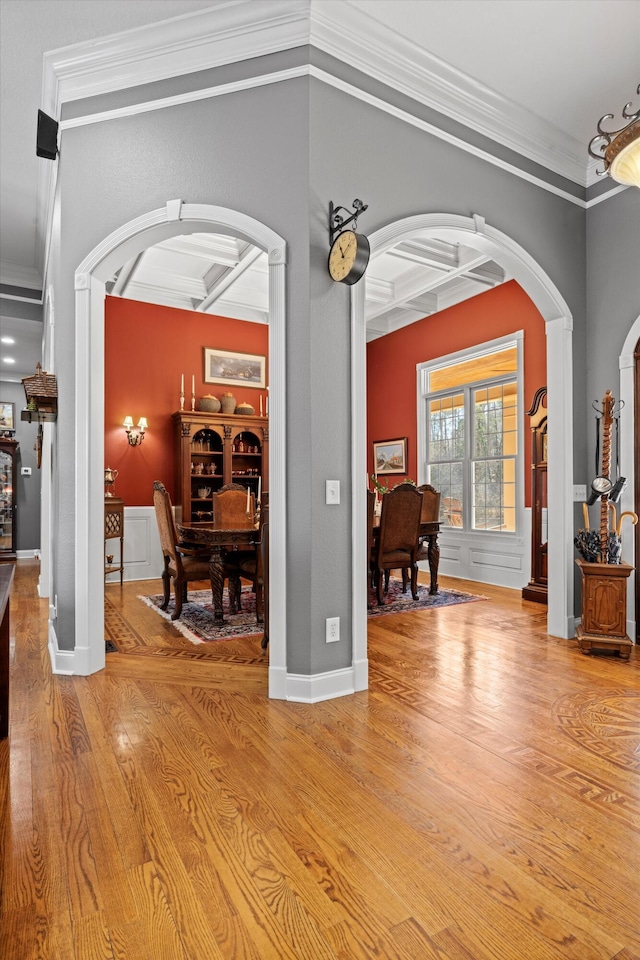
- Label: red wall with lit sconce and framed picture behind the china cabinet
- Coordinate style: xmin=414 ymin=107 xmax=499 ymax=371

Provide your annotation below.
xmin=104 ymin=297 xmax=269 ymax=506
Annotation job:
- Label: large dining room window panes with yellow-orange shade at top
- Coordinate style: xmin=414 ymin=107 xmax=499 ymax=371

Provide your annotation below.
xmin=420 ymin=340 xmax=520 ymax=534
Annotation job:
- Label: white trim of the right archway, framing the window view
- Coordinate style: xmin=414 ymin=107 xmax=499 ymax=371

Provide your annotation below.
xmin=351 ymin=213 xmax=575 ymax=672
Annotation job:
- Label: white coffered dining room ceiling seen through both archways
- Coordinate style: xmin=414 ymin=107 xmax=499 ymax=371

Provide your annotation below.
xmin=107 ymin=233 xmax=509 ymax=340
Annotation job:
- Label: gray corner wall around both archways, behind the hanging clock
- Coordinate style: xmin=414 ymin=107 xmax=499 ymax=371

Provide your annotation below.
xmin=52 ymin=48 xmax=586 ymax=674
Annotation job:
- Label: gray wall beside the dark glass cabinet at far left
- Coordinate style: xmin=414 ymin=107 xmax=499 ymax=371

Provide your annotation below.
xmin=0 ymin=380 xmax=41 ymax=550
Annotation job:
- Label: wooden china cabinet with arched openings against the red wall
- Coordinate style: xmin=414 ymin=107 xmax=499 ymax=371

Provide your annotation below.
xmin=173 ymin=410 xmax=269 ymax=524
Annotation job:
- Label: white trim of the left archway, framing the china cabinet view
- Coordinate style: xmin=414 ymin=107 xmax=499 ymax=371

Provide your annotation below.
xmin=60 ymin=200 xmax=287 ymax=698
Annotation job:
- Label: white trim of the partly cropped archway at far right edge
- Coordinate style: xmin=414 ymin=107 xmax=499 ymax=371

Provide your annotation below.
xmin=619 ymin=317 xmax=640 ymax=643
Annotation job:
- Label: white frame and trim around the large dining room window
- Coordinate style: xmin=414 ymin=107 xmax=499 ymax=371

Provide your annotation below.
xmin=416 ymin=330 xmax=528 ymax=545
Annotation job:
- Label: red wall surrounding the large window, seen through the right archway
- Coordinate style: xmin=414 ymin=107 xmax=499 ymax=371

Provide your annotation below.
xmin=367 ymin=280 xmax=547 ymax=506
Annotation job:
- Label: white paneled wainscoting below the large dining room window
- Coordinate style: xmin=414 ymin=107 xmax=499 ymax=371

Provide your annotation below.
xmin=428 ymin=507 xmax=531 ymax=590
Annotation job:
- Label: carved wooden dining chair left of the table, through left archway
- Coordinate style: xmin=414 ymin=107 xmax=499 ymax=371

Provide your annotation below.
xmin=153 ymin=480 xmax=214 ymax=620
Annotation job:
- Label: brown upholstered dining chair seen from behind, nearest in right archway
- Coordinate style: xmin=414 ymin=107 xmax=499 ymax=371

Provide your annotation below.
xmin=374 ymin=483 xmax=422 ymax=605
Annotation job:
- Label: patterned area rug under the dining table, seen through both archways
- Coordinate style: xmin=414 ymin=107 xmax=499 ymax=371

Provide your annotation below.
xmin=138 ymin=578 xmax=487 ymax=643
